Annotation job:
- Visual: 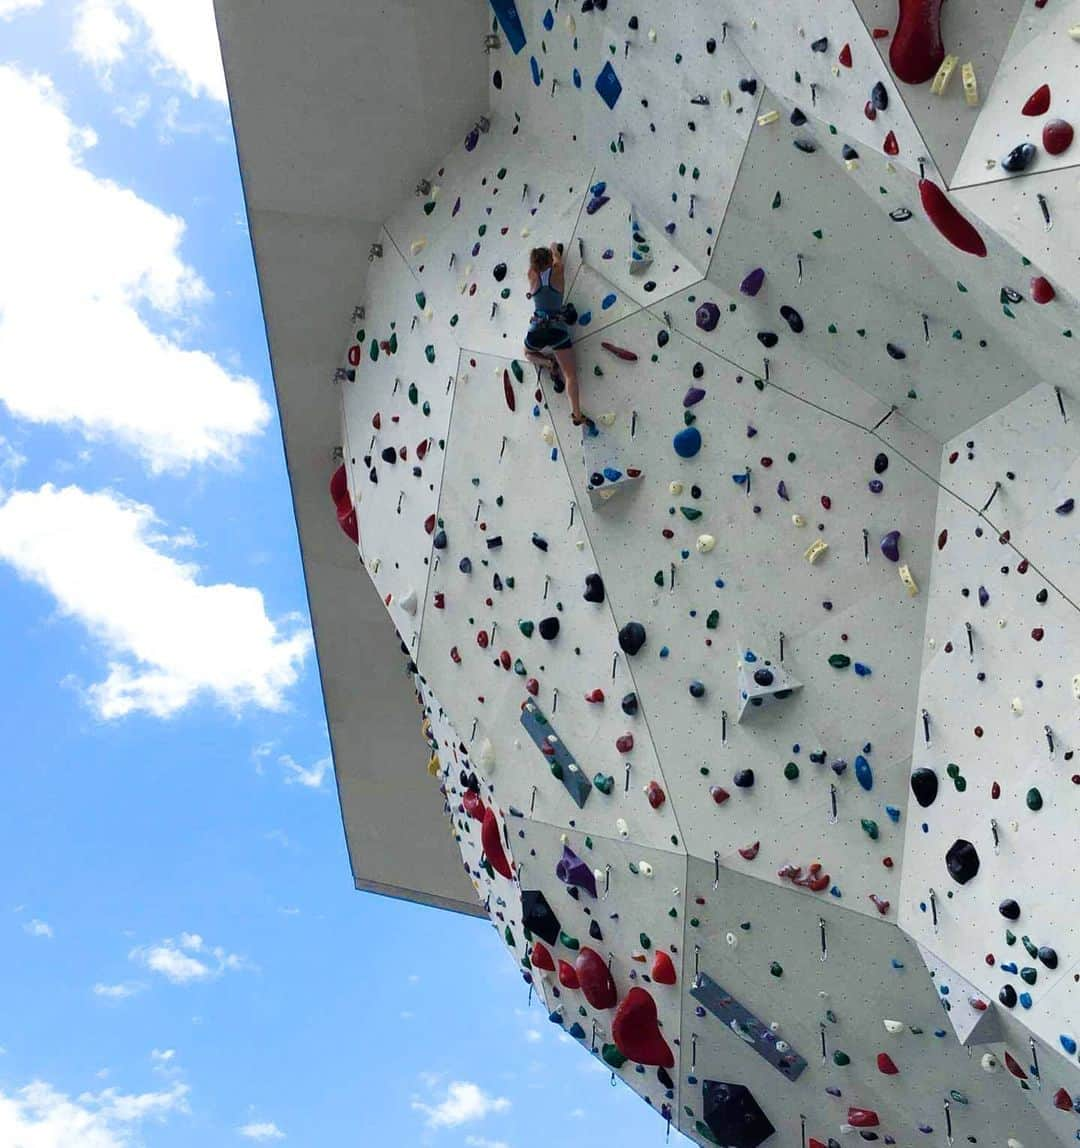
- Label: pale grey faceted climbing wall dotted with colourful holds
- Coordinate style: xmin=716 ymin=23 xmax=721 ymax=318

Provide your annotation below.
xmin=332 ymin=0 xmax=1080 ymax=1148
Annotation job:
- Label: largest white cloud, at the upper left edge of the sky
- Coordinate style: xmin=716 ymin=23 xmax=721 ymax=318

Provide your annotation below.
xmin=0 ymin=66 xmax=271 ymax=472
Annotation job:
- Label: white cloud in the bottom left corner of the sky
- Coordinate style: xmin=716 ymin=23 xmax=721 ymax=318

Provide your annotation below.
xmin=0 ymin=1080 xmax=189 ymax=1148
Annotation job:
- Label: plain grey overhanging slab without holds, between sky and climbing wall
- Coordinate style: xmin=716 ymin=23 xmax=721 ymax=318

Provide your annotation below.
xmin=216 ymin=0 xmax=488 ymax=913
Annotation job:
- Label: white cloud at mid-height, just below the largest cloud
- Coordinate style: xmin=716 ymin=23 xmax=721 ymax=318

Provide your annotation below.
xmin=0 ymin=486 xmax=311 ymax=719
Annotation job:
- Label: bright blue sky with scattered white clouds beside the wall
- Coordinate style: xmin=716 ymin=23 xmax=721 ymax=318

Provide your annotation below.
xmin=0 ymin=0 xmax=675 ymax=1148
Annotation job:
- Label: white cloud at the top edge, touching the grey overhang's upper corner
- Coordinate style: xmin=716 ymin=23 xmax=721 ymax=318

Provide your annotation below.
xmin=72 ymin=0 xmax=226 ymax=103
